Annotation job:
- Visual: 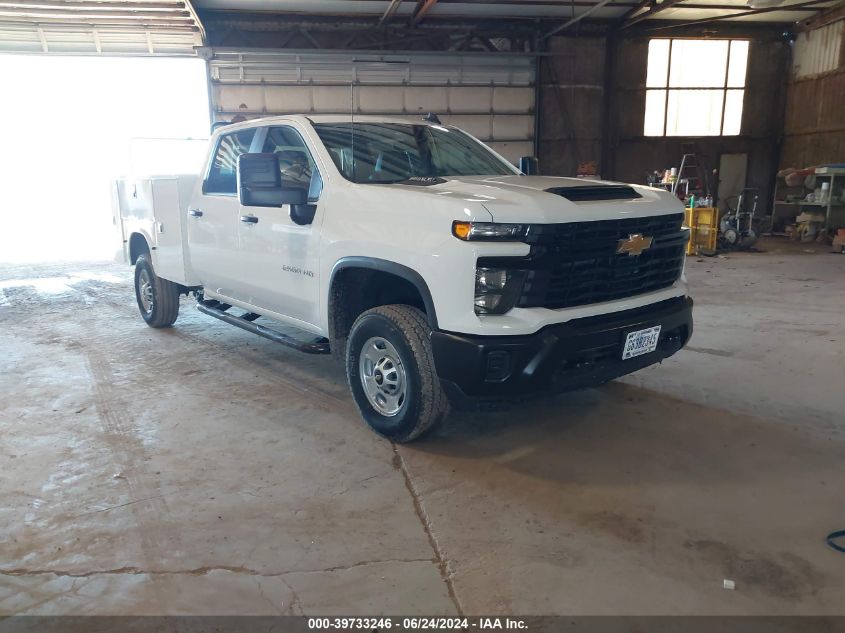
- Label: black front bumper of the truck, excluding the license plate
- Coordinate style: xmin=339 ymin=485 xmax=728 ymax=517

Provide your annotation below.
xmin=431 ymin=297 xmax=693 ymax=400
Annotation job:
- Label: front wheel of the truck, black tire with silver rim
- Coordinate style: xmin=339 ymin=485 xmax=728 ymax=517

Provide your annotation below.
xmin=346 ymin=305 xmax=449 ymax=443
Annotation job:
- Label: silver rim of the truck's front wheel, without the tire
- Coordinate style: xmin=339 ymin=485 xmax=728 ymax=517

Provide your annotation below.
xmin=358 ymin=336 xmax=407 ymax=417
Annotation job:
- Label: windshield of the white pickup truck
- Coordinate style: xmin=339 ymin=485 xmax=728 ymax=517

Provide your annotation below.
xmin=314 ymin=123 xmax=519 ymax=183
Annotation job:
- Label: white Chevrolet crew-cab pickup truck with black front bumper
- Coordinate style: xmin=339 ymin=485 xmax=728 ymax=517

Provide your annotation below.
xmin=116 ymin=116 xmax=692 ymax=442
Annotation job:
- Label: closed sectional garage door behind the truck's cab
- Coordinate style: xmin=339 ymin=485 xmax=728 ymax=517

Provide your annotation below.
xmin=209 ymin=49 xmax=536 ymax=161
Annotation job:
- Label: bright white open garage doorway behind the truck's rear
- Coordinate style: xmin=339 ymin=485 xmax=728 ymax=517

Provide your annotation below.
xmin=0 ymin=55 xmax=209 ymax=263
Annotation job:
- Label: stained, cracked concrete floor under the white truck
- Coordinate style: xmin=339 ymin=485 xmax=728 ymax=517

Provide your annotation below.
xmin=0 ymin=236 xmax=845 ymax=615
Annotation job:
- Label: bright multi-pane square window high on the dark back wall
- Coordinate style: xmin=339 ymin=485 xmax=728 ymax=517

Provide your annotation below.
xmin=643 ymin=39 xmax=748 ymax=136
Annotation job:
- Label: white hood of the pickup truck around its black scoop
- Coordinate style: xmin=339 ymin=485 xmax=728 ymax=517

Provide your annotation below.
xmin=390 ymin=175 xmax=683 ymax=224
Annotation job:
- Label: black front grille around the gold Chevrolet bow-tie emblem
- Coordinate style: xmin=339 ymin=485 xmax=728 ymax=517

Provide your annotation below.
xmin=478 ymin=214 xmax=688 ymax=309
